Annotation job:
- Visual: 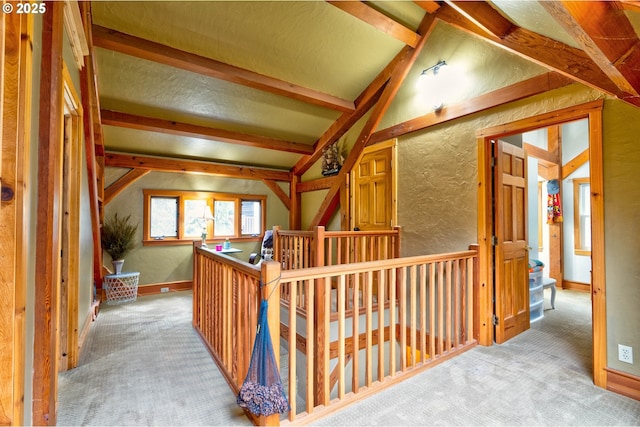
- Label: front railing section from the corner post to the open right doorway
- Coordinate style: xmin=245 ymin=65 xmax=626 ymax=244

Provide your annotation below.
xmin=280 ymin=251 xmax=477 ymax=424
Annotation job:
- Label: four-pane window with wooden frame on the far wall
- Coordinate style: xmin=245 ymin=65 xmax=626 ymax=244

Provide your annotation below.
xmin=143 ymin=190 xmax=266 ymax=245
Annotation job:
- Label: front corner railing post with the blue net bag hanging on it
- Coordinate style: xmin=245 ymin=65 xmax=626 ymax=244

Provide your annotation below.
xmin=257 ymin=260 xmax=282 ymax=426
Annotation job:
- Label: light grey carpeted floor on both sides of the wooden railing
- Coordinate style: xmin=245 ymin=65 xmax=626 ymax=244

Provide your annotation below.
xmin=58 ymin=291 xmax=640 ymax=426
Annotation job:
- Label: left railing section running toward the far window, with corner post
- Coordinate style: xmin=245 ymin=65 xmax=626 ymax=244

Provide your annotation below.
xmin=193 ymin=242 xmax=280 ymax=425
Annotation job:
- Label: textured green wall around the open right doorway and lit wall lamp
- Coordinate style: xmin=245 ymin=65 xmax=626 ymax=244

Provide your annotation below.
xmin=303 ymin=26 xmax=640 ymax=375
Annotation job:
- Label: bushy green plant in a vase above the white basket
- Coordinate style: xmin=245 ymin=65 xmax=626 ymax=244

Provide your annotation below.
xmin=100 ymin=213 xmax=138 ymax=274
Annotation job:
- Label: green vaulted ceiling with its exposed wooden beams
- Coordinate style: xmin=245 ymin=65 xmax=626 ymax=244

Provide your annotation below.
xmin=89 ymin=0 xmax=640 ymax=186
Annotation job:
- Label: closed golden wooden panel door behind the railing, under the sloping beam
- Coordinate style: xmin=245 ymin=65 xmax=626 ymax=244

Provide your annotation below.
xmin=351 ymin=140 xmax=395 ymax=231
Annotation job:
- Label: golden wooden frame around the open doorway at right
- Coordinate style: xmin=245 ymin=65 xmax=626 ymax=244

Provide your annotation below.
xmin=476 ymin=100 xmax=607 ymax=388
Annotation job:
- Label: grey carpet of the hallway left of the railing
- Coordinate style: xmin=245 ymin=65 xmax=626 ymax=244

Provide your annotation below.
xmin=58 ymin=292 xmax=252 ymax=426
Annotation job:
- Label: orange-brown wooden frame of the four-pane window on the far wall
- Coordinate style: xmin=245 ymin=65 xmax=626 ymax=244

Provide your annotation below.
xmin=142 ymin=189 xmax=267 ymax=246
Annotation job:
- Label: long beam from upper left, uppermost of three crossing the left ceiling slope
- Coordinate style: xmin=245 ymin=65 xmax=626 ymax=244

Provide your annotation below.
xmin=93 ymin=25 xmax=355 ymax=112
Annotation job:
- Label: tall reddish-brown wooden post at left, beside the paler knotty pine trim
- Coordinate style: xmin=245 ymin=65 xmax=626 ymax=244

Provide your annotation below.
xmin=32 ymin=1 xmax=64 ymax=425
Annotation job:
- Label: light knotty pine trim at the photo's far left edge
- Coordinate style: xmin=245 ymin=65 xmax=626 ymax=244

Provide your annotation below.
xmin=0 ymin=10 xmax=33 ymax=425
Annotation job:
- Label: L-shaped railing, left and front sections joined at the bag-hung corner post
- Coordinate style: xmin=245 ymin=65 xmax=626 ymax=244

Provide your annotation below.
xmin=193 ymin=244 xmax=478 ymax=425
